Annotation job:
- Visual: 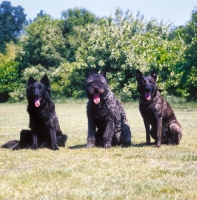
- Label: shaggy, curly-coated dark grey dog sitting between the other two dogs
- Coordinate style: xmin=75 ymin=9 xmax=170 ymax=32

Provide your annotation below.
xmin=86 ymin=70 xmax=131 ymax=148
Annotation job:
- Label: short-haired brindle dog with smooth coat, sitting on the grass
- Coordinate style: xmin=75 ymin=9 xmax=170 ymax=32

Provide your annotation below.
xmin=136 ymin=70 xmax=182 ymax=147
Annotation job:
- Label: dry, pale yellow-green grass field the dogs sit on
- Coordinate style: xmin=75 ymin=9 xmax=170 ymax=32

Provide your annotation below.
xmin=0 ymin=100 xmax=197 ymax=200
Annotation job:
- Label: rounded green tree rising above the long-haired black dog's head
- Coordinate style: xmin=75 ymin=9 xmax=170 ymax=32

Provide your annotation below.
xmin=19 ymin=14 xmax=66 ymax=69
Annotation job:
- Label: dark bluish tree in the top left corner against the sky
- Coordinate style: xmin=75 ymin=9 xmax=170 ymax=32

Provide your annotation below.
xmin=0 ymin=1 xmax=26 ymax=52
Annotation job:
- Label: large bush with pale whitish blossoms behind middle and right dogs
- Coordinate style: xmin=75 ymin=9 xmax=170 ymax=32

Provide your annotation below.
xmin=70 ymin=10 xmax=184 ymax=100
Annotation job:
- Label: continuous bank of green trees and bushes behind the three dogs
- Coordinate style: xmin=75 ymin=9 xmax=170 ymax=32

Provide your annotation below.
xmin=0 ymin=4 xmax=197 ymax=101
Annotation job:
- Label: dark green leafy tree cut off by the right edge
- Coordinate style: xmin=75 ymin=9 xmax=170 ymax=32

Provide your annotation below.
xmin=176 ymin=8 xmax=197 ymax=99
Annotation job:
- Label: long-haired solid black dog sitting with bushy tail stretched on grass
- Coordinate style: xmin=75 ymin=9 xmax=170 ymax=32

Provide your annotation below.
xmin=1 ymin=75 xmax=67 ymax=150
